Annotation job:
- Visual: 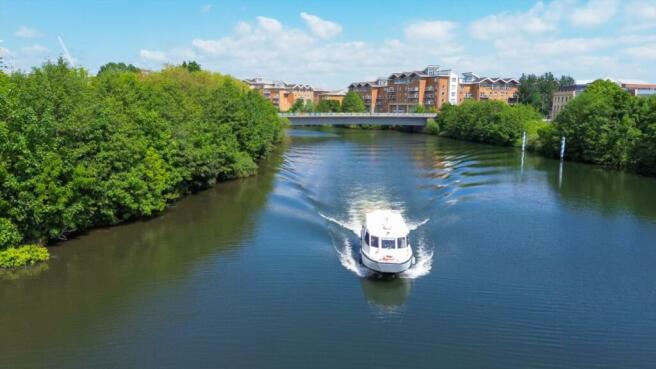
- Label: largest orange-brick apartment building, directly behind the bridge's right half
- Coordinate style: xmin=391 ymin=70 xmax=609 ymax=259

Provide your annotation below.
xmin=349 ymin=65 xmax=458 ymax=113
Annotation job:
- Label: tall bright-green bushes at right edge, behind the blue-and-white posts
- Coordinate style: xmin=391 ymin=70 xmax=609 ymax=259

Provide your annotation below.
xmin=540 ymin=80 xmax=656 ymax=174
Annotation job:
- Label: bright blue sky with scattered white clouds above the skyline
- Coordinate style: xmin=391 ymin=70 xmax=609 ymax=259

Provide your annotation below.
xmin=0 ymin=0 xmax=656 ymax=88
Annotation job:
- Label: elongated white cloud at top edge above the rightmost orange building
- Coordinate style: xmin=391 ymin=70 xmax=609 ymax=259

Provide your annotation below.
xmin=469 ymin=0 xmax=569 ymax=40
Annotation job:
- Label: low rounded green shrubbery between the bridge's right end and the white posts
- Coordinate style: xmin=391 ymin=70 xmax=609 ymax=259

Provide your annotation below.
xmin=437 ymin=101 xmax=541 ymax=146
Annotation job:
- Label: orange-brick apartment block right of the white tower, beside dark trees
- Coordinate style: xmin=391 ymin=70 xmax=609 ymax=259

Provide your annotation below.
xmin=458 ymin=72 xmax=519 ymax=104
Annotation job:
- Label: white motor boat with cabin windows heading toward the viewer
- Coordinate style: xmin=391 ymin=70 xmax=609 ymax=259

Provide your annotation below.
xmin=360 ymin=210 xmax=415 ymax=274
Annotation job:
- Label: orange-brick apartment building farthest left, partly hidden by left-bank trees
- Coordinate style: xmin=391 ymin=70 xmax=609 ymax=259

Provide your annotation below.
xmin=244 ymin=78 xmax=315 ymax=111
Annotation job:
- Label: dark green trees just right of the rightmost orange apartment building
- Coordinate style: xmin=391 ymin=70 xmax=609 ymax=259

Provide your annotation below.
xmin=517 ymin=73 xmax=575 ymax=116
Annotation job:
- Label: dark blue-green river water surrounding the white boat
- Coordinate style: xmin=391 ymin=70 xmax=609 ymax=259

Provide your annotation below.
xmin=0 ymin=129 xmax=656 ymax=369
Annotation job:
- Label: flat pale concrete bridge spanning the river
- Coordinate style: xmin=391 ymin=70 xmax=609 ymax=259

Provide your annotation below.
xmin=280 ymin=113 xmax=437 ymax=127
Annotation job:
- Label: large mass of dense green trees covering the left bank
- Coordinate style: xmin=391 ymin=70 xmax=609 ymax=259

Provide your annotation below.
xmin=0 ymin=60 xmax=281 ymax=248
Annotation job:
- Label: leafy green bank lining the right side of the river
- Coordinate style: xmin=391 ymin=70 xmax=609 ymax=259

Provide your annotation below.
xmin=426 ymin=81 xmax=656 ymax=176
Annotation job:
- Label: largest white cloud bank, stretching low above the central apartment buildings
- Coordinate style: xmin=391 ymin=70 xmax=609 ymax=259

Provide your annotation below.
xmin=187 ymin=17 xmax=462 ymax=88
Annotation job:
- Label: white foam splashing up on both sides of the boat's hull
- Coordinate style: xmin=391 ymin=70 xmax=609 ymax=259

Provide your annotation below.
xmin=319 ymin=213 xmax=434 ymax=279
